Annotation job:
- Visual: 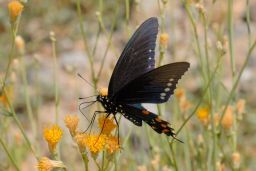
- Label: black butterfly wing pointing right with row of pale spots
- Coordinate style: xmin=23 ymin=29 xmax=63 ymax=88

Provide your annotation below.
xmin=113 ymin=62 xmax=189 ymax=104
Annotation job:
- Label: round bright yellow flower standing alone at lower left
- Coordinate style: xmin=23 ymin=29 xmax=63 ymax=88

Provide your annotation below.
xmin=44 ymin=124 xmax=63 ymax=152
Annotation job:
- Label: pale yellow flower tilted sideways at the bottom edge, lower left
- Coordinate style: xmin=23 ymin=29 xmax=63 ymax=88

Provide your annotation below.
xmin=36 ymin=157 xmax=66 ymax=171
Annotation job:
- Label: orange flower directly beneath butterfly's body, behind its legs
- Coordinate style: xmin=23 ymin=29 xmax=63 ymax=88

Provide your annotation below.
xmin=98 ymin=115 xmax=116 ymax=135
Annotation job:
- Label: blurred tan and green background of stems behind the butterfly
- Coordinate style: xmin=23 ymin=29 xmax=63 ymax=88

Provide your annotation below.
xmin=0 ymin=0 xmax=256 ymax=171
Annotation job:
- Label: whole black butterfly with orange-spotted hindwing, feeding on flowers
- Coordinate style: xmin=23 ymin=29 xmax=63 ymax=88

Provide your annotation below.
xmin=83 ymin=17 xmax=189 ymax=142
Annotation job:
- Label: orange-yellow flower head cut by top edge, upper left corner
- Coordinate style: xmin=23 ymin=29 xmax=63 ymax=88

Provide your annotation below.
xmin=8 ymin=1 xmax=24 ymax=22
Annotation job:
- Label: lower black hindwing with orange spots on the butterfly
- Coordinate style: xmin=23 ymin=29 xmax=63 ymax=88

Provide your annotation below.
xmin=122 ymin=105 xmax=175 ymax=137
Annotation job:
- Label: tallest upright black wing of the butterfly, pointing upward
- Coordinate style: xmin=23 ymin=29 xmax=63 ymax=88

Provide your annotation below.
xmin=108 ymin=17 xmax=158 ymax=98
